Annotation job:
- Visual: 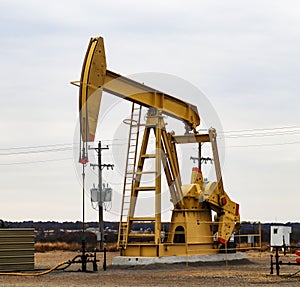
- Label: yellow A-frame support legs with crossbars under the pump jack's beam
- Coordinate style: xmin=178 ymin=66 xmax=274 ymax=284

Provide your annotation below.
xmin=119 ymin=108 xmax=183 ymax=256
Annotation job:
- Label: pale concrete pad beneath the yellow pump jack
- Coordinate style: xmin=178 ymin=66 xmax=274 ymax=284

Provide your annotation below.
xmin=112 ymin=253 xmax=247 ymax=266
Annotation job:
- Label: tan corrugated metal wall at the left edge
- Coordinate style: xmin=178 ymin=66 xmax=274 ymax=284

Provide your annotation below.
xmin=0 ymin=228 xmax=34 ymax=271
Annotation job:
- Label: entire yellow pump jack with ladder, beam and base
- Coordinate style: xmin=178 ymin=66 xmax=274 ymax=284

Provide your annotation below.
xmin=74 ymin=37 xmax=240 ymax=257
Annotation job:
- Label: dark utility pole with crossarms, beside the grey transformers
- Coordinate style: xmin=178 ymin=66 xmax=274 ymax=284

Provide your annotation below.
xmin=91 ymin=141 xmax=114 ymax=251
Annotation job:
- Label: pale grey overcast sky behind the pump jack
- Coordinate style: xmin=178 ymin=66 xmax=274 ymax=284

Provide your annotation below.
xmin=0 ymin=0 xmax=300 ymax=222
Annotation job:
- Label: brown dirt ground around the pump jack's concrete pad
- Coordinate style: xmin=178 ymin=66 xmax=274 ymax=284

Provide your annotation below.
xmin=0 ymin=251 xmax=300 ymax=287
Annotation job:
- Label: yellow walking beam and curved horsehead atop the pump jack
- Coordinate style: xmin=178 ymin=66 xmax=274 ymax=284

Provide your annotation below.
xmin=79 ymin=37 xmax=200 ymax=142
